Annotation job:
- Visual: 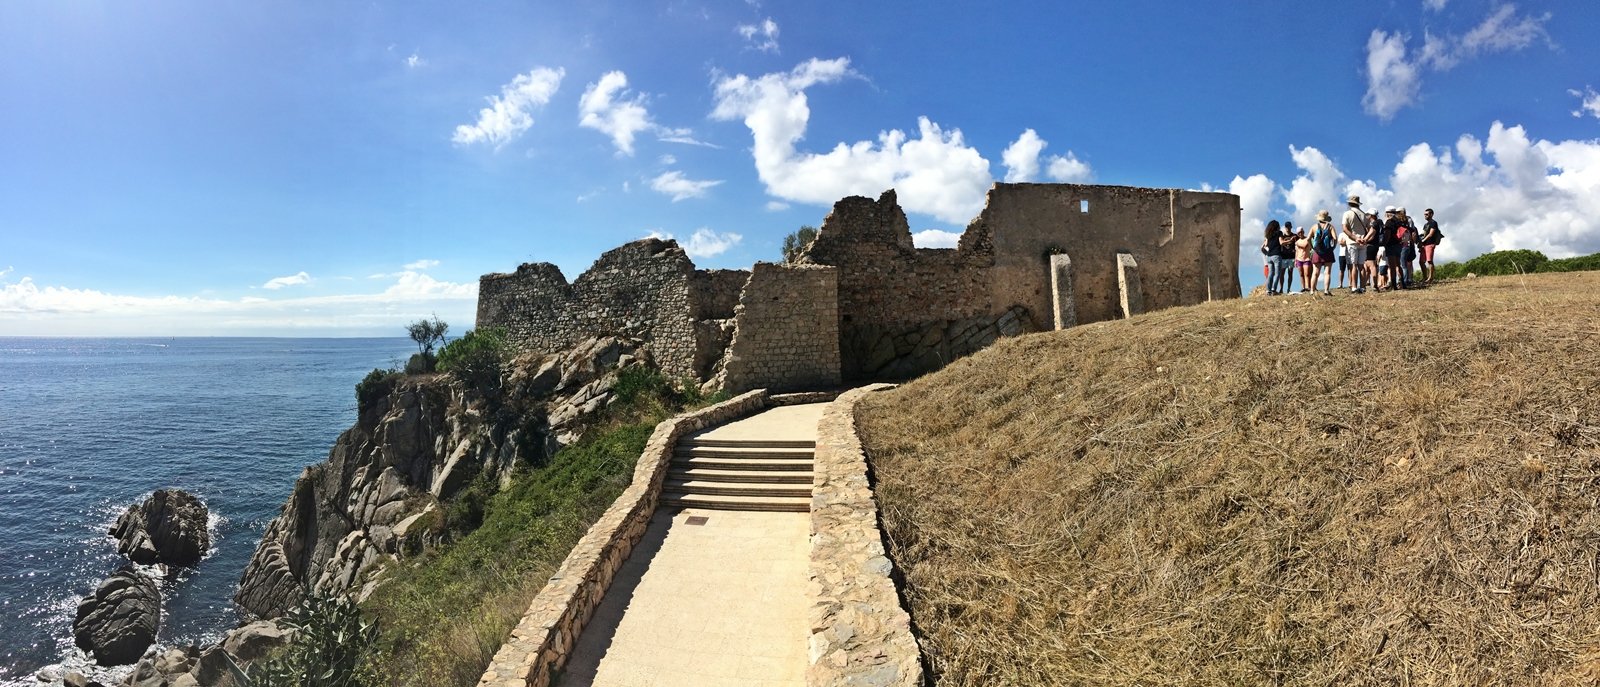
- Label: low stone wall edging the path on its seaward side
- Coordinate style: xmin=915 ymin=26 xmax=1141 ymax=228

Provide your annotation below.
xmin=478 ymin=389 xmax=768 ymax=687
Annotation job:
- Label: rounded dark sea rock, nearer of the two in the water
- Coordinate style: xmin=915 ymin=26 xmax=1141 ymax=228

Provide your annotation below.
xmin=72 ymin=570 xmax=162 ymax=666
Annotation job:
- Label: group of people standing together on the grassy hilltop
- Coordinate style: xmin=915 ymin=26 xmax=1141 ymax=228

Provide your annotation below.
xmin=1261 ymin=195 xmax=1445 ymax=296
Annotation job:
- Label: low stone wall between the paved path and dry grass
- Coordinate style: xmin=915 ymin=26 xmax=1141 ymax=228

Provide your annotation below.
xmin=805 ymin=384 xmax=923 ymax=687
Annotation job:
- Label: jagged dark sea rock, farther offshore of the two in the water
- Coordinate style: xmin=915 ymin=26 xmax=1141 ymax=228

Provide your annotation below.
xmin=110 ymin=488 xmax=211 ymax=567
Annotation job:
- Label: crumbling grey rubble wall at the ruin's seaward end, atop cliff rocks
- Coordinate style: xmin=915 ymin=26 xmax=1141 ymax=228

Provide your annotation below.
xmin=477 ymin=239 xmax=701 ymax=378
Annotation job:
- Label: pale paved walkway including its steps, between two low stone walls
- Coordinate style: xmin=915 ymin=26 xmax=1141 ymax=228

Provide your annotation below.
xmin=558 ymin=404 xmax=827 ymax=687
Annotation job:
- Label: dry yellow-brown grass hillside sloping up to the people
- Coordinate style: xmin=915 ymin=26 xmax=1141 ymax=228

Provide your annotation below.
xmin=859 ymin=272 xmax=1600 ymax=685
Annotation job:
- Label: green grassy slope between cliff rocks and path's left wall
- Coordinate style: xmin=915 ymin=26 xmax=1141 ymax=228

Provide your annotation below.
xmin=365 ymin=361 xmax=726 ymax=687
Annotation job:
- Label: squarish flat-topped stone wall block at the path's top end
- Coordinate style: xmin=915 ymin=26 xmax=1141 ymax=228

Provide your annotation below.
xmin=722 ymin=263 xmax=840 ymax=394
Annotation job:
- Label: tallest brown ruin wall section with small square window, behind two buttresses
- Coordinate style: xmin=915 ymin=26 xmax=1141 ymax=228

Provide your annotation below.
xmin=800 ymin=184 xmax=1238 ymax=381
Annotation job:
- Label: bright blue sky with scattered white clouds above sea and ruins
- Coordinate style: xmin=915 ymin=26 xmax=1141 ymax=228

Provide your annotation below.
xmin=0 ymin=0 xmax=1600 ymax=336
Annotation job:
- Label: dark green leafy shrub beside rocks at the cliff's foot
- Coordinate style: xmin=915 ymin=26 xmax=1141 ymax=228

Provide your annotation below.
xmin=248 ymin=594 xmax=378 ymax=687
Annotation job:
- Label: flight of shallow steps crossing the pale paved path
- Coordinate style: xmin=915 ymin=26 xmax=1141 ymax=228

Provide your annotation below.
xmin=661 ymin=439 xmax=816 ymax=512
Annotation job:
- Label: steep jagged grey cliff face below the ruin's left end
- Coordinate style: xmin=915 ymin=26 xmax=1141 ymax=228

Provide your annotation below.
xmin=234 ymin=336 xmax=651 ymax=618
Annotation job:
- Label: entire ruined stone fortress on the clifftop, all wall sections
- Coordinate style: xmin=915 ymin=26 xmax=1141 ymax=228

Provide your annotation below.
xmin=477 ymin=184 xmax=1240 ymax=391
